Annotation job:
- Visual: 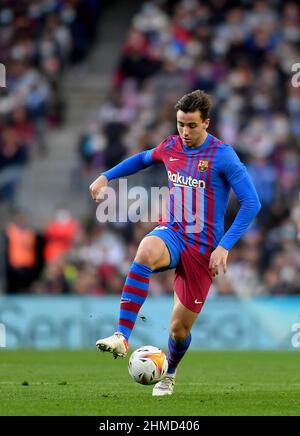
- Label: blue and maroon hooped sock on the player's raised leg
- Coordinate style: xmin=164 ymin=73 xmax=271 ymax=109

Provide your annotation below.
xmin=118 ymin=262 xmax=152 ymax=340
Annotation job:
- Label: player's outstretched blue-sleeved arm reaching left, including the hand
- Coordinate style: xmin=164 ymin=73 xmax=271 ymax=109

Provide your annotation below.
xmin=90 ymin=148 xmax=156 ymax=203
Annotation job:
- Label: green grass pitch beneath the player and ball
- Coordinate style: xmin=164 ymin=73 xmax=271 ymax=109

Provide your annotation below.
xmin=0 ymin=350 xmax=300 ymax=416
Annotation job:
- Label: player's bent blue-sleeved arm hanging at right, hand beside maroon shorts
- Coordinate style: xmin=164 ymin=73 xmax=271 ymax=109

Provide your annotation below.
xmin=210 ymin=147 xmax=261 ymax=275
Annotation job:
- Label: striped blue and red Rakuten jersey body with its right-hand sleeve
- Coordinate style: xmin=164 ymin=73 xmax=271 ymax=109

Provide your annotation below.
xmin=148 ymin=134 xmax=260 ymax=253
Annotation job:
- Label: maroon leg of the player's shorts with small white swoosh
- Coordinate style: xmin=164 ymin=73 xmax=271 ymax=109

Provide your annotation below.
xmin=174 ymin=246 xmax=212 ymax=313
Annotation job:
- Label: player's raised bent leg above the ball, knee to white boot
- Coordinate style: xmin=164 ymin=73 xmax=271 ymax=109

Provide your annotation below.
xmin=96 ymin=236 xmax=171 ymax=357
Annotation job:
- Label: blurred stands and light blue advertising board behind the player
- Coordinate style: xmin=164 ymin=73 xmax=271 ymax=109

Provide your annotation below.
xmin=0 ymin=0 xmax=300 ymax=348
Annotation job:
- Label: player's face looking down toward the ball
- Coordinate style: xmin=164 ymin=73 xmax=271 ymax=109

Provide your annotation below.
xmin=177 ymin=110 xmax=209 ymax=147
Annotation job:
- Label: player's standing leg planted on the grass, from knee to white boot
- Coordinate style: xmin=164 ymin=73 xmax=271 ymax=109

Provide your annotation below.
xmin=152 ymin=293 xmax=198 ymax=396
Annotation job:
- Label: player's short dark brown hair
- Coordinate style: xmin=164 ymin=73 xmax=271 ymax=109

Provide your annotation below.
xmin=175 ymin=89 xmax=212 ymax=121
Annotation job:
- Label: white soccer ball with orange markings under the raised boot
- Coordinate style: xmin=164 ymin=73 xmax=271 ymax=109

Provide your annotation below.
xmin=128 ymin=345 xmax=168 ymax=385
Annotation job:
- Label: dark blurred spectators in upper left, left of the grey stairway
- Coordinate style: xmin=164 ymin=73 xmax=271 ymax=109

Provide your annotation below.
xmin=0 ymin=0 xmax=101 ymax=205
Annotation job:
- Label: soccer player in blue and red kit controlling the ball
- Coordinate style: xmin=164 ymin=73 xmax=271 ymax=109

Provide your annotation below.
xmin=90 ymin=90 xmax=260 ymax=396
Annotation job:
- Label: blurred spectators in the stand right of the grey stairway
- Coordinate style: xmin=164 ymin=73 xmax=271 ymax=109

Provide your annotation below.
xmin=0 ymin=0 xmax=300 ymax=297
